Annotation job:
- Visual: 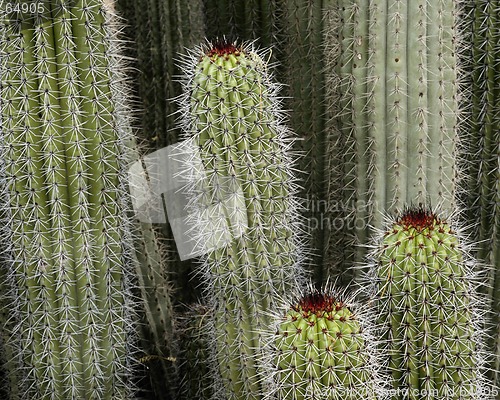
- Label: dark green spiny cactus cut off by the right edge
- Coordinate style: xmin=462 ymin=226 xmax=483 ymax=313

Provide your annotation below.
xmin=461 ymin=0 xmax=500 ymax=384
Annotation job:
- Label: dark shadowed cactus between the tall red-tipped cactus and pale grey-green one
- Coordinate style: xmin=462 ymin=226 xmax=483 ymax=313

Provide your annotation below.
xmin=275 ymin=0 xmax=328 ymax=284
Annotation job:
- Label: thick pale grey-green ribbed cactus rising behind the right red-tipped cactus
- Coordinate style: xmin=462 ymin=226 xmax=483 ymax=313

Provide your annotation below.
xmin=325 ymin=0 xmax=460 ymax=282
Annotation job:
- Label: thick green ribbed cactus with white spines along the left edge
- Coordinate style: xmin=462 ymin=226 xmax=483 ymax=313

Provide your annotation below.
xmin=0 ymin=0 xmax=134 ymax=400
